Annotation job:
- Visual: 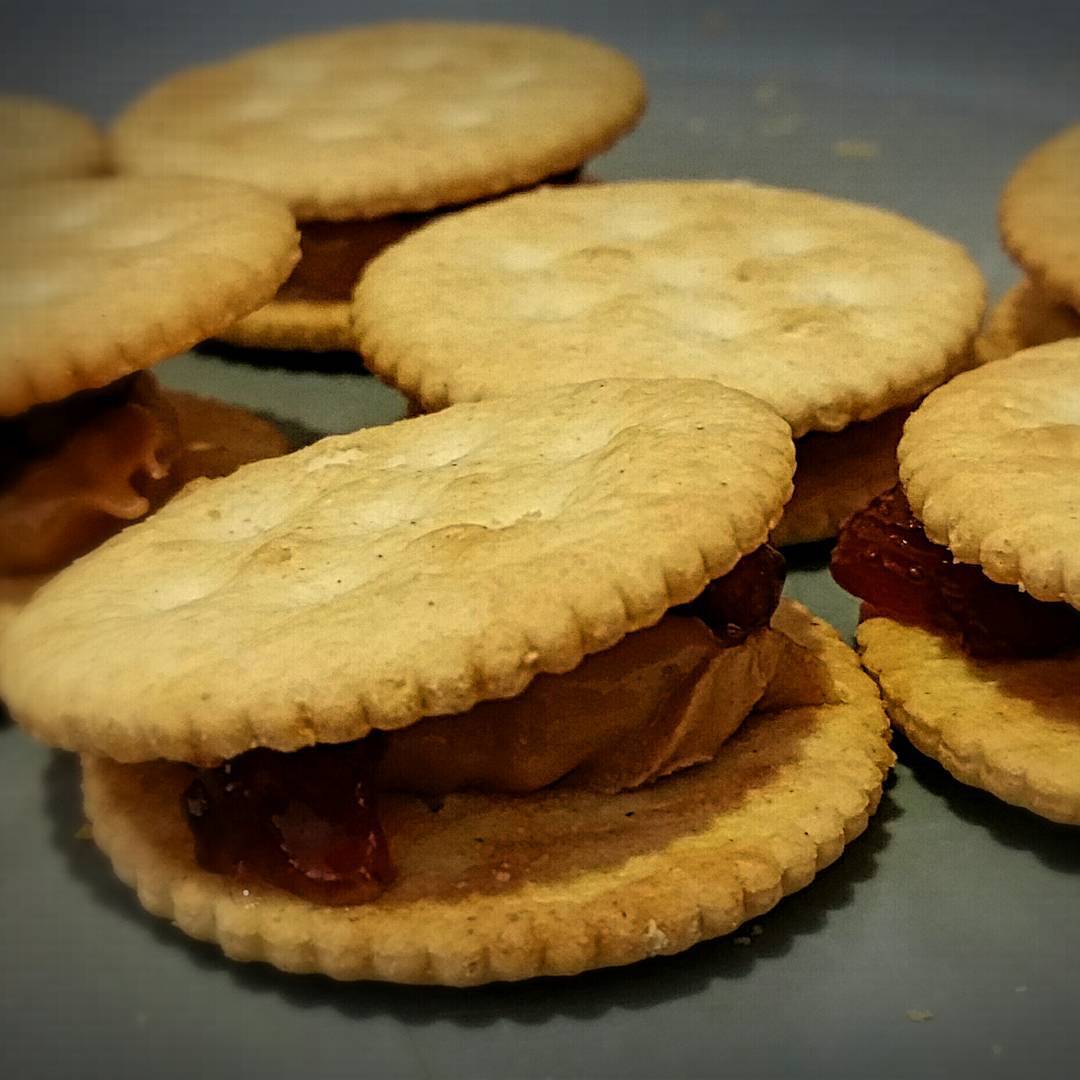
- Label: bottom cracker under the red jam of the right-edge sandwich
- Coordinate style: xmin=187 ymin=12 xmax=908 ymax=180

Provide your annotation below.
xmin=859 ymin=618 xmax=1080 ymax=825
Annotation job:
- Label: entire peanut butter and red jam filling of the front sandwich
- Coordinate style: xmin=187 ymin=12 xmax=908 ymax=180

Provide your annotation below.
xmin=184 ymin=548 xmax=823 ymax=904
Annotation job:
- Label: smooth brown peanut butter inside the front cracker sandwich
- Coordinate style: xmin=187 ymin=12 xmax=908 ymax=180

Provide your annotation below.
xmin=376 ymin=615 xmax=827 ymax=795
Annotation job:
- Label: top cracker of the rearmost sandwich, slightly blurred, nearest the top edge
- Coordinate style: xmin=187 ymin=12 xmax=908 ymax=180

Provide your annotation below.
xmin=113 ymin=22 xmax=645 ymax=220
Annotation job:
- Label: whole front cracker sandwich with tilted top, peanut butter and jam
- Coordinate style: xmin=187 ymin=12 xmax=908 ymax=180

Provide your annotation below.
xmin=0 ymin=380 xmax=892 ymax=985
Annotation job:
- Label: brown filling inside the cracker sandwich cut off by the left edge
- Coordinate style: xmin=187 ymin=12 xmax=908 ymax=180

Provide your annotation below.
xmin=0 ymin=373 xmax=180 ymax=576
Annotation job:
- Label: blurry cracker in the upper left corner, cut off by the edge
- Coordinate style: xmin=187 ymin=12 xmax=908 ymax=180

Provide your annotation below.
xmin=0 ymin=94 xmax=105 ymax=184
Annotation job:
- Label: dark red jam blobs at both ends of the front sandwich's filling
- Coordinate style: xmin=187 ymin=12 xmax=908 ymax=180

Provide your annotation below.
xmin=183 ymin=545 xmax=785 ymax=904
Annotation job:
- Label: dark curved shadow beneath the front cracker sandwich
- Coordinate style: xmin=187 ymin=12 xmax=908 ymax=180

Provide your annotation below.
xmin=43 ymin=751 xmax=903 ymax=1028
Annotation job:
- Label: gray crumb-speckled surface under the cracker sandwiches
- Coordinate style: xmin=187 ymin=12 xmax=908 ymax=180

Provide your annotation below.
xmin=0 ymin=0 xmax=1080 ymax=1080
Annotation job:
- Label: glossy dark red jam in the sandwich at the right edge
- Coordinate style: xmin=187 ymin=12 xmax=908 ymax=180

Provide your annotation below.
xmin=832 ymin=484 xmax=1080 ymax=658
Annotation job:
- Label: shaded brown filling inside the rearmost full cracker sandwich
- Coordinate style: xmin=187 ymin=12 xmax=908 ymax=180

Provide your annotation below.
xmin=278 ymin=170 xmax=581 ymax=302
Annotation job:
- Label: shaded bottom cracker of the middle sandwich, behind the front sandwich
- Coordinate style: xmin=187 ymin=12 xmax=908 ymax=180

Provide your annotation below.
xmin=772 ymin=408 xmax=909 ymax=546
